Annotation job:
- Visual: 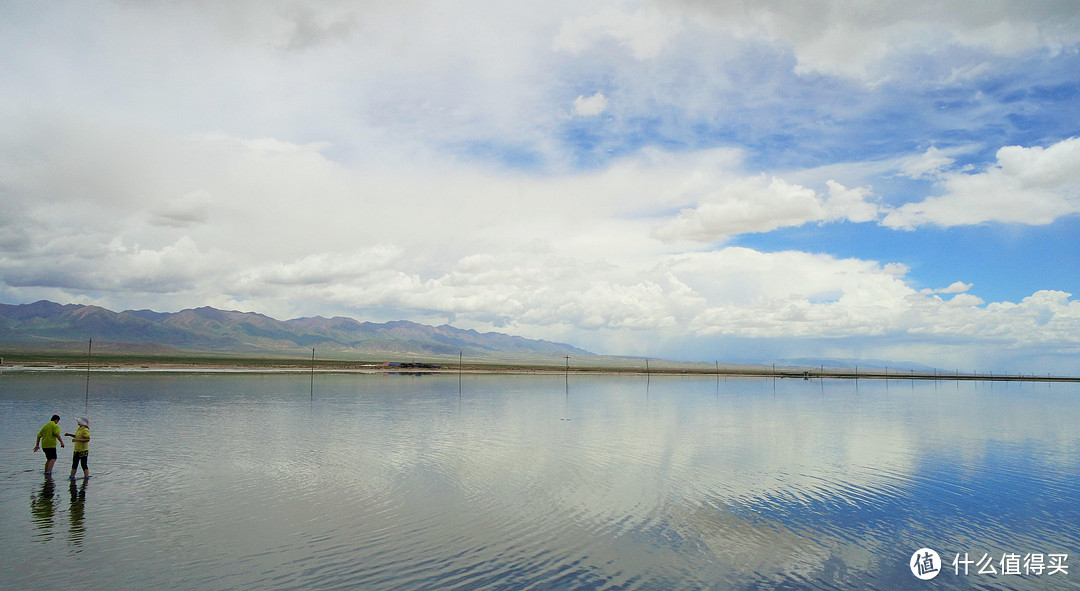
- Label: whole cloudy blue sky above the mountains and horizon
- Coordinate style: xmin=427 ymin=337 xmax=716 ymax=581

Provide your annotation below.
xmin=0 ymin=0 xmax=1080 ymax=375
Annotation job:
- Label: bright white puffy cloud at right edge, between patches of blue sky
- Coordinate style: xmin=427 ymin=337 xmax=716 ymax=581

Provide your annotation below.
xmin=881 ymin=137 xmax=1080 ymax=230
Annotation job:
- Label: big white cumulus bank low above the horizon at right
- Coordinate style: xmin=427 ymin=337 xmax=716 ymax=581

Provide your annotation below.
xmin=656 ymin=247 xmax=1080 ymax=352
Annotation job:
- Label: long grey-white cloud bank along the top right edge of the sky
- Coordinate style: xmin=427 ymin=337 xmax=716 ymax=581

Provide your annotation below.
xmin=553 ymin=0 xmax=1080 ymax=82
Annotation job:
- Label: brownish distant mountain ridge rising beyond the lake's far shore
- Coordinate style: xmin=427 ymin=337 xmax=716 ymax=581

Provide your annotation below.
xmin=0 ymin=300 xmax=593 ymax=357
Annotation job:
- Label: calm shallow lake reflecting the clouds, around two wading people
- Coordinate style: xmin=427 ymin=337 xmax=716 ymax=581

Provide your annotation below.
xmin=0 ymin=371 xmax=1080 ymax=590
